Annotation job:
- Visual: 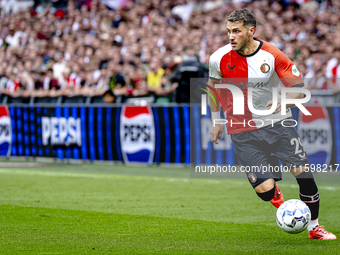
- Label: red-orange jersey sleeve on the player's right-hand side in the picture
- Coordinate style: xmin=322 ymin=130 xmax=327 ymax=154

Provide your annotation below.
xmin=275 ymin=51 xmax=304 ymax=87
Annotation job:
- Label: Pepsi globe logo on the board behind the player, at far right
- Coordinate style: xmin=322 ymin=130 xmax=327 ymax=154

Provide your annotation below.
xmin=298 ymin=106 xmax=333 ymax=165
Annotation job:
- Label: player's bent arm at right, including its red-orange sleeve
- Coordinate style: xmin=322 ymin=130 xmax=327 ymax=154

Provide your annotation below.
xmin=267 ymin=51 xmax=304 ymax=114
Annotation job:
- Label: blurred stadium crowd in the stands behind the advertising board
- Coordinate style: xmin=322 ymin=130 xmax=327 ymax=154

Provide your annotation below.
xmin=0 ymin=0 xmax=340 ymax=102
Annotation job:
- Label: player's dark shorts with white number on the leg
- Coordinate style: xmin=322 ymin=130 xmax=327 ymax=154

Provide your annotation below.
xmin=230 ymin=120 xmax=309 ymax=188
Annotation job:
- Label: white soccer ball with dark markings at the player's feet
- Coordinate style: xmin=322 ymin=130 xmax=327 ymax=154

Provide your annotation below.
xmin=276 ymin=199 xmax=311 ymax=234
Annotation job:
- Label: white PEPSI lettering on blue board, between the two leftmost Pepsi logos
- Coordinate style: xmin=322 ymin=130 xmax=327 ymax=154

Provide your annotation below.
xmin=41 ymin=117 xmax=81 ymax=146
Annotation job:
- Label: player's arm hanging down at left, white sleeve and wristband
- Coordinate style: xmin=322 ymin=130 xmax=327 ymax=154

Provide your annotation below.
xmin=208 ymin=51 xmax=223 ymax=144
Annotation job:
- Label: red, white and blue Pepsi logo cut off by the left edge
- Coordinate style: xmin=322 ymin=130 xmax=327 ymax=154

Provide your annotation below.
xmin=0 ymin=106 xmax=12 ymax=157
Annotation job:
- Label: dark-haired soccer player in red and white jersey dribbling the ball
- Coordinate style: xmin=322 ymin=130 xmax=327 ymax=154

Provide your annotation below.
xmin=208 ymin=8 xmax=336 ymax=240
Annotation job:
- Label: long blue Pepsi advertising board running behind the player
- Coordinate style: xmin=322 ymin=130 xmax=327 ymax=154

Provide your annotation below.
xmin=4 ymin=105 xmax=340 ymax=165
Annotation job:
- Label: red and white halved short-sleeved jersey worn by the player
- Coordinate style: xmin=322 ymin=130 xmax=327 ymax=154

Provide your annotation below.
xmin=209 ymin=38 xmax=304 ymax=134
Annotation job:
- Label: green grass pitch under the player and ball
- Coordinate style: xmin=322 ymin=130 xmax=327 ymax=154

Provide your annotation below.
xmin=0 ymin=164 xmax=340 ymax=254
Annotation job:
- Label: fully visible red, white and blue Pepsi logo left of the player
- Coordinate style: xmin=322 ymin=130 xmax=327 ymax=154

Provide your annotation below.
xmin=120 ymin=105 xmax=155 ymax=164
